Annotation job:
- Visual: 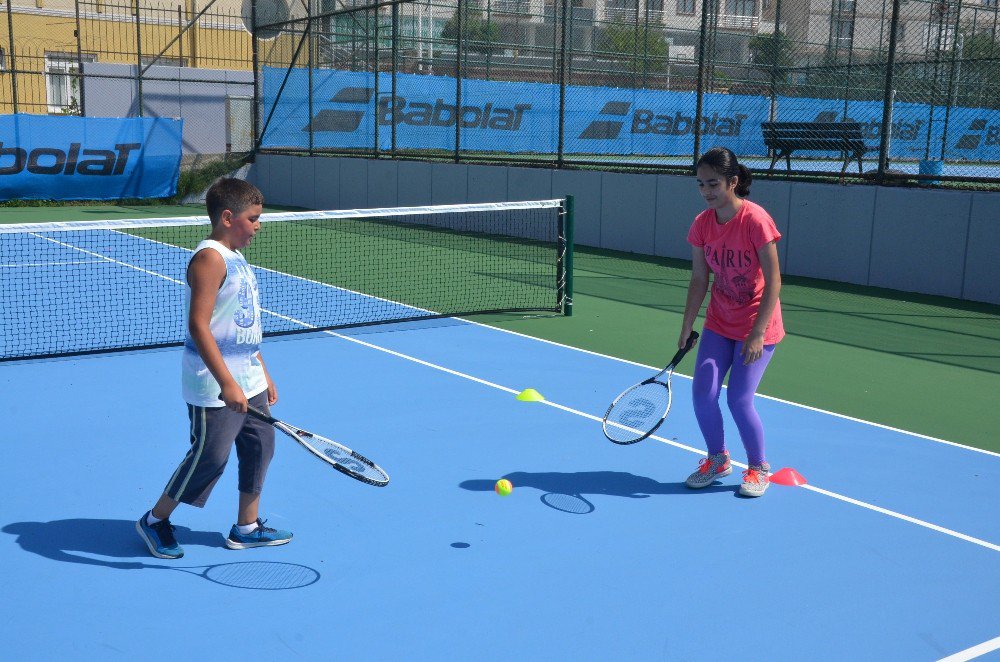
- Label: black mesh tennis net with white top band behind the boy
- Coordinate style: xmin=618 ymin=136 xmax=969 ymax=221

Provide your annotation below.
xmin=0 ymin=200 xmax=572 ymax=361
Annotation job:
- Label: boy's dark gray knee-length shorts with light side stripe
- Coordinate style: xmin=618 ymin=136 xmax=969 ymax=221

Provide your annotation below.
xmin=164 ymin=391 xmax=274 ymax=508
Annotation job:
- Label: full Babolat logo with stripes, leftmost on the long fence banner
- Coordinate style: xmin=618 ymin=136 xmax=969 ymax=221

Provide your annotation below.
xmin=302 ymin=87 xmax=531 ymax=133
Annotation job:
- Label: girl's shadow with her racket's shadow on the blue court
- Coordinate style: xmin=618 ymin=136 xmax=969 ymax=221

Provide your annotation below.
xmin=459 ymin=471 xmax=739 ymax=515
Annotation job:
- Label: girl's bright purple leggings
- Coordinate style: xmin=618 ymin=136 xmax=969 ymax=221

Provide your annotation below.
xmin=691 ymin=329 xmax=774 ymax=464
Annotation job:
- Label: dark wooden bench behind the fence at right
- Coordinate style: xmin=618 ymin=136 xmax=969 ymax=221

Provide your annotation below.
xmin=761 ymin=122 xmax=874 ymax=176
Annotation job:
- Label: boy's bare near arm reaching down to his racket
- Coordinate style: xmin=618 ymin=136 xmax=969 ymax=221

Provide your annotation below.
xmin=187 ymin=250 xmax=247 ymax=413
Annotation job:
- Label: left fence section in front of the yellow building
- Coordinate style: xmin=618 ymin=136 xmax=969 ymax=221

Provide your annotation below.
xmin=0 ymin=0 xmax=254 ymax=194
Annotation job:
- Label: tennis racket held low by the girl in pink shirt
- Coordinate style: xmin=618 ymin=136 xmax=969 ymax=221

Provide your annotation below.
xmin=604 ymin=331 xmax=698 ymax=445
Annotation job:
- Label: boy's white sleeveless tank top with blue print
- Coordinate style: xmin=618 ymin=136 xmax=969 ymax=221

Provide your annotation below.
xmin=181 ymin=239 xmax=267 ymax=407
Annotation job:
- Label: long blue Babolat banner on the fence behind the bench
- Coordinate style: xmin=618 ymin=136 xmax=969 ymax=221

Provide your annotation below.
xmin=262 ymin=68 xmax=1000 ymax=161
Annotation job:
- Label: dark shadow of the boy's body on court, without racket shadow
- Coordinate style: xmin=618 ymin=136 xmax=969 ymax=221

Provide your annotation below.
xmin=0 ymin=519 xmax=225 ymax=570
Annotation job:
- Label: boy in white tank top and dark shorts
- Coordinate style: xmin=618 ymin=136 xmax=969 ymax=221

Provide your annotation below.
xmin=135 ymin=178 xmax=292 ymax=559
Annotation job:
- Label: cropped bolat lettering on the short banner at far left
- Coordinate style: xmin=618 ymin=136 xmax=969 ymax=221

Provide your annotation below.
xmin=0 ymin=142 xmax=142 ymax=176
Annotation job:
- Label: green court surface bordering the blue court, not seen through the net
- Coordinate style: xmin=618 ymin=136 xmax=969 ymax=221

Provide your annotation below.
xmin=7 ymin=206 xmax=1000 ymax=452
